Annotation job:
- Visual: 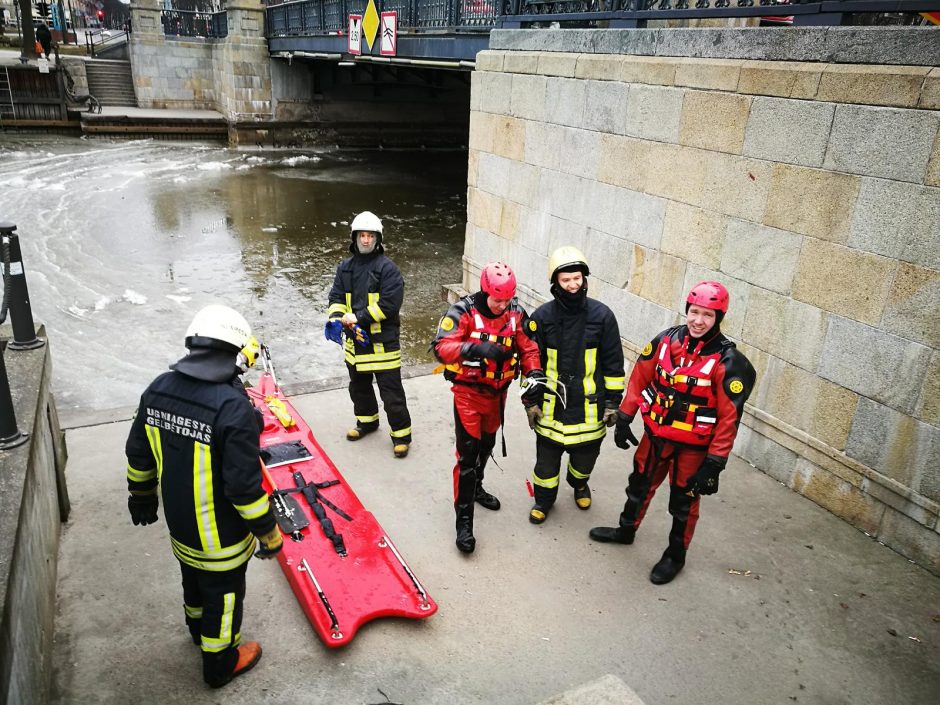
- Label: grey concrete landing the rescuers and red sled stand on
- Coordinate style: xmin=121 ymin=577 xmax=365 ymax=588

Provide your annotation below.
xmin=52 ymin=376 xmax=940 ymax=705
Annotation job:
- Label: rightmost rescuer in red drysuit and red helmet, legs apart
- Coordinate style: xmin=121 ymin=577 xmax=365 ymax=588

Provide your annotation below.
xmin=590 ymin=281 xmax=756 ymax=585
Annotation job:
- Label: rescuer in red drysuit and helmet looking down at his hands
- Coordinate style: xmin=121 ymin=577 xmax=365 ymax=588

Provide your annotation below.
xmin=431 ymin=262 xmax=542 ymax=553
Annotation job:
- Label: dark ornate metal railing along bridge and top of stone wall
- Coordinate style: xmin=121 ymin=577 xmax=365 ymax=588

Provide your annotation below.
xmin=265 ymin=0 xmax=940 ymax=37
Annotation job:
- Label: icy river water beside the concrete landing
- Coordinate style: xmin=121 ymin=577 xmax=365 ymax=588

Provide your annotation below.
xmin=0 ymin=135 xmax=467 ymax=413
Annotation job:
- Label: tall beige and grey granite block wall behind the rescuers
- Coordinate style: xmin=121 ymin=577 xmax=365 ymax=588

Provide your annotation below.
xmin=463 ymin=28 xmax=940 ymax=574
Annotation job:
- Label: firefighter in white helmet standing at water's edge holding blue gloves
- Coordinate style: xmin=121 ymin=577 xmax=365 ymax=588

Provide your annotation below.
xmin=328 ymin=211 xmax=411 ymax=458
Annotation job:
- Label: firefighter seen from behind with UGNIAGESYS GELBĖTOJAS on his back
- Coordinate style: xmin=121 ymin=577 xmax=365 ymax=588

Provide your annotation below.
xmin=126 ymin=305 xmax=282 ymax=688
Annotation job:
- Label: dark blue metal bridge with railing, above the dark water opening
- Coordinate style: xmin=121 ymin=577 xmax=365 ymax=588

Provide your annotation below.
xmin=265 ymin=0 xmax=940 ymax=63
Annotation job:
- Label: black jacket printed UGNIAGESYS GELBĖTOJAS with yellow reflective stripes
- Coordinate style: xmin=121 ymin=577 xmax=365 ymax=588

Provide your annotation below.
xmin=125 ymin=372 xmax=274 ymax=571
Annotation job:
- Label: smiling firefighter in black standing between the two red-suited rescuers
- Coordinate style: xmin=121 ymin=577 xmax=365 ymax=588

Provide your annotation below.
xmin=526 ymin=247 xmax=624 ymax=524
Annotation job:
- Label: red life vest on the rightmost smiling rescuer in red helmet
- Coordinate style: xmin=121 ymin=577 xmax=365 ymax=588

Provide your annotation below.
xmin=640 ymin=336 xmax=722 ymax=446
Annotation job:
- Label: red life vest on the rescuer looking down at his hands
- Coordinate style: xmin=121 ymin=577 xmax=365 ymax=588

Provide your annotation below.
xmin=444 ymin=305 xmax=525 ymax=389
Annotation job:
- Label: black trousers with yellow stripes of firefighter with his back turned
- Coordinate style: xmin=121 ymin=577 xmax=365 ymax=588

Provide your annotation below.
xmin=180 ymin=561 xmax=248 ymax=685
